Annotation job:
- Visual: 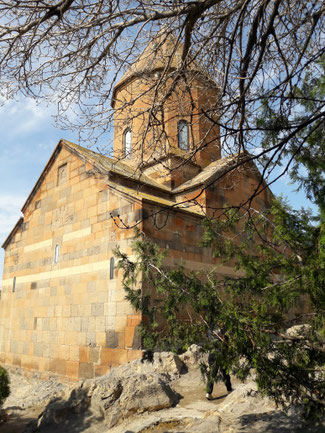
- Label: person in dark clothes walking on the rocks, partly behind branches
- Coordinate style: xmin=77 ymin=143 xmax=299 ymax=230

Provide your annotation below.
xmin=205 ymin=325 xmax=233 ymax=400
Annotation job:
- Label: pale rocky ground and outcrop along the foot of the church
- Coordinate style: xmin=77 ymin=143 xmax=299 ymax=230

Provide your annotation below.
xmin=3 ymin=345 xmax=325 ymax=433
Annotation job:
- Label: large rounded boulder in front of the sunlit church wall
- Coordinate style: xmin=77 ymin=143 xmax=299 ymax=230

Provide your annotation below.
xmin=32 ymin=369 xmax=180 ymax=432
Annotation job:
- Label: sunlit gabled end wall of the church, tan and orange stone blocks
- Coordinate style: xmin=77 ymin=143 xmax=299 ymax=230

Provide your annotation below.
xmin=0 ymin=148 xmax=141 ymax=379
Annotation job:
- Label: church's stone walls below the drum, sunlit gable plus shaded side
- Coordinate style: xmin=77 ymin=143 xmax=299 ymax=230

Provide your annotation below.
xmin=0 ymin=144 xmax=271 ymax=379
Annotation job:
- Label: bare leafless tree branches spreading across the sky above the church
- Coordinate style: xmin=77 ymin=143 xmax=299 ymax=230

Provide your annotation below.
xmin=0 ymin=0 xmax=325 ymax=189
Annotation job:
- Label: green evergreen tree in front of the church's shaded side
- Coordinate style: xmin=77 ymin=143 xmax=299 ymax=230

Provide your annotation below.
xmin=117 ymin=59 xmax=325 ymax=413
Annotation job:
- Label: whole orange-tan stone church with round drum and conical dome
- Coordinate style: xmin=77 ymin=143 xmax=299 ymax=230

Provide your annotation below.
xmin=0 ymin=36 xmax=272 ymax=380
